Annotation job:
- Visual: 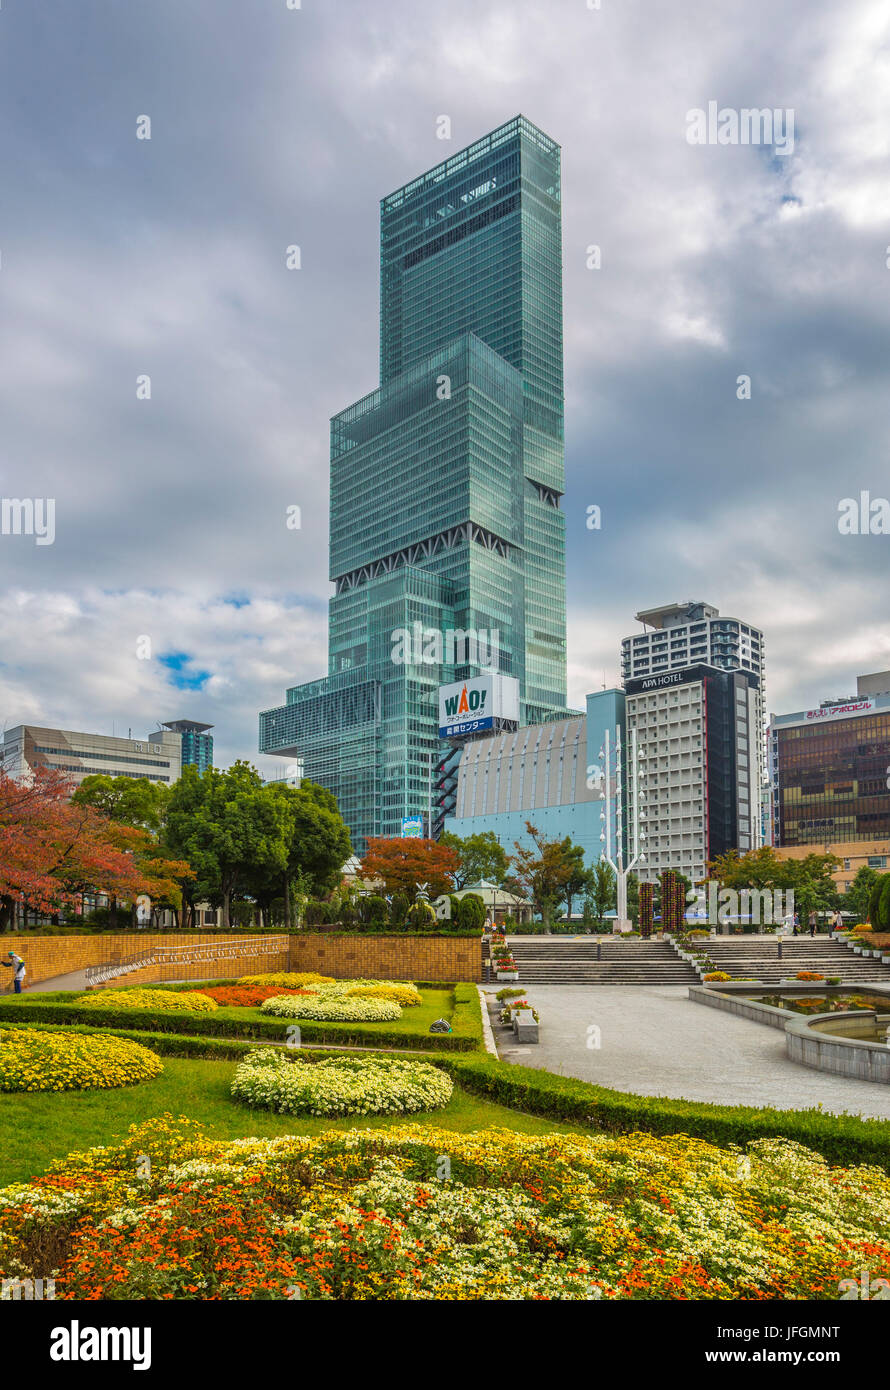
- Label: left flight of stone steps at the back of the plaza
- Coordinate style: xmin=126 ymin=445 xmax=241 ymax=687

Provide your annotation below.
xmin=485 ymin=935 xmax=698 ymax=987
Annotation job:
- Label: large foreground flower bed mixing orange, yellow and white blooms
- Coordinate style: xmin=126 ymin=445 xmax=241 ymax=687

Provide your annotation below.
xmin=6 ymin=1112 xmax=890 ymax=1302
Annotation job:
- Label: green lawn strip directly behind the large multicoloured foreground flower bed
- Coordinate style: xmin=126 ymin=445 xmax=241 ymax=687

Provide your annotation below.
xmin=0 ymin=1056 xmax=580 ymax=1187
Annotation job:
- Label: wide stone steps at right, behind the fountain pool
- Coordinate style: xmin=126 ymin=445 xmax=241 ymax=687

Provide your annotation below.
xmin=701 ymin=935 xmax=890 ymax=984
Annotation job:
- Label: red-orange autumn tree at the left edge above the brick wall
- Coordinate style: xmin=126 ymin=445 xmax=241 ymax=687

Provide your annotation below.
xmin=0 ymin=767 xmax=192 ymax=930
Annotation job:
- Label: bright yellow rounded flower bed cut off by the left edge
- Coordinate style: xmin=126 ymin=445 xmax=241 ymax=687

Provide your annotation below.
xmin=0 ymin=1029 xmax=164 ymax=1091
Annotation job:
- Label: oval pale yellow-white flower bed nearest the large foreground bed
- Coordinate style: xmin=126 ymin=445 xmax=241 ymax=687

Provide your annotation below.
xmin=232 ymin=1048 xmax=453 ymax=1115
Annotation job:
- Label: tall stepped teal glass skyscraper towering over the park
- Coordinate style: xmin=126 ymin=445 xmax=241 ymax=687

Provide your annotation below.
xmin=260 ymin=117 xmax=566 ymax=852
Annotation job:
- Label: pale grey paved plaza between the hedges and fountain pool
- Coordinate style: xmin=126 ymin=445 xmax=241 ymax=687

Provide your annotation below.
xmin=485 ymin=984 xmax=890 ymax=1119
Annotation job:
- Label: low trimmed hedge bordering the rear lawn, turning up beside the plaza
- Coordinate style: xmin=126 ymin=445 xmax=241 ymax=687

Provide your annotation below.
xmin=0 ymin=984 xmax=483 ymax=1052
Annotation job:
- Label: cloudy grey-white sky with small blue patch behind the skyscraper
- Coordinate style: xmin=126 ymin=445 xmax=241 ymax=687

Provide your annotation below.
xmin=0 ymin=0 xmax=890 ymax=773
